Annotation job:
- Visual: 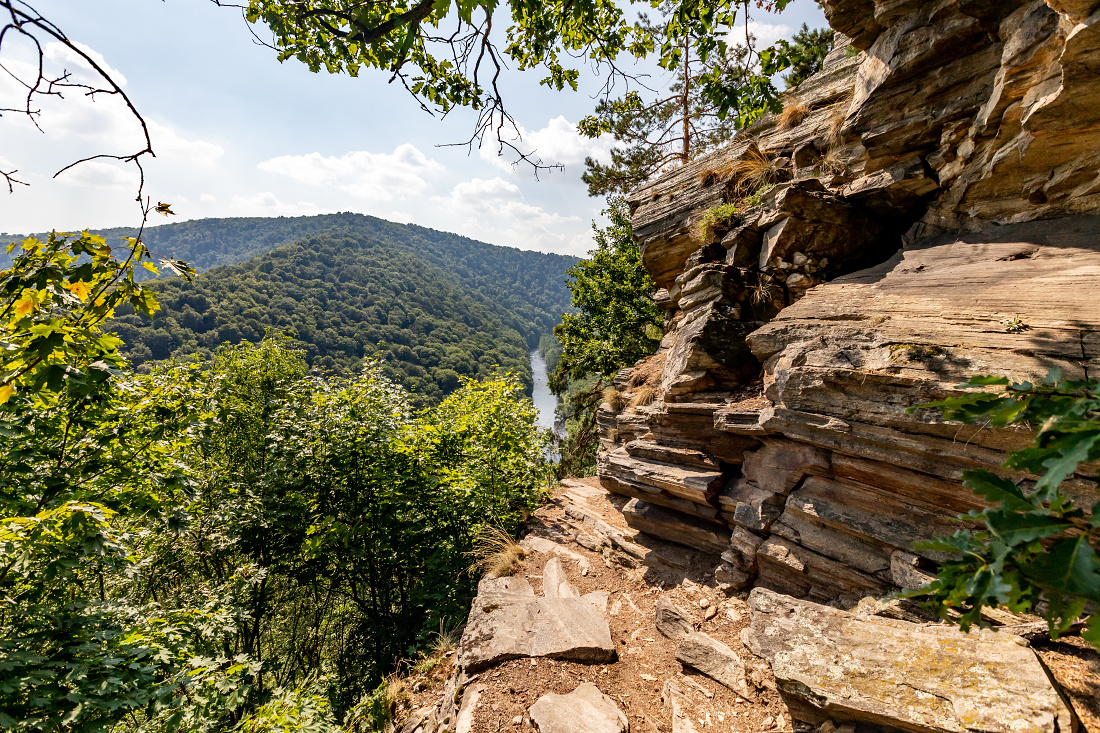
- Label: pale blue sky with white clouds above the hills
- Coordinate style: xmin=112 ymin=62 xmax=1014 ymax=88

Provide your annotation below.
xmin=0 ymin=0 xmax=825 ymax=255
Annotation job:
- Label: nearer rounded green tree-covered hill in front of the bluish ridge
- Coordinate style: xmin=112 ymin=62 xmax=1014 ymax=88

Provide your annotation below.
xmin=111 ymin=229 xmax=563 ymax=404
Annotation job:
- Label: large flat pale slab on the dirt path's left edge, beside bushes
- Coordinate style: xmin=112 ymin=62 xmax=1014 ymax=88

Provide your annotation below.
xmin=458 ymin=558 xmax=615 ymax=674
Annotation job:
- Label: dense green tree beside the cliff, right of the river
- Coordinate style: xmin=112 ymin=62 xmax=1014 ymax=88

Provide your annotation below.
xmin=551 ymin=197 xmax=663 ymax=389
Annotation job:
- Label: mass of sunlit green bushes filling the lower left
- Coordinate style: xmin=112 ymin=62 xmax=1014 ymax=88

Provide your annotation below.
xmin=0 ymin=226 xmax=548 ymax=733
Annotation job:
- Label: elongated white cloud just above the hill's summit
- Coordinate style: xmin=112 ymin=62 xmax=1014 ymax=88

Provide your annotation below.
xmin=257 ymin=143 xmax=444 ymax=201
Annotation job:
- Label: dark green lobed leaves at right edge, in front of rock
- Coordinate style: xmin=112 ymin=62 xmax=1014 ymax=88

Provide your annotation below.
xmin=914 ymin=370 xmax=1100 ymax=648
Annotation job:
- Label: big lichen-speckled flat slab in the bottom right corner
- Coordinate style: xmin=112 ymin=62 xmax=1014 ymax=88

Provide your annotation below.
xmin=741 ymin=588 xmax=1073 ymax=733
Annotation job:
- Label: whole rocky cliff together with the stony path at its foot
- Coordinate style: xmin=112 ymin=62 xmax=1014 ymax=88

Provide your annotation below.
xmin=400 ymin=0 xmax=1100 ymax=733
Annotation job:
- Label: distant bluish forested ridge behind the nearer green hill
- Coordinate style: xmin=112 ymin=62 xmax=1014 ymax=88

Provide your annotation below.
xmin=0 ymin=211 xmax=578 ymax=349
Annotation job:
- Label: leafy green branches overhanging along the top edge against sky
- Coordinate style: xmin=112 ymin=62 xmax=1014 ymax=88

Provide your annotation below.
xmin=245 ymin=0 xmax=789 ymax=124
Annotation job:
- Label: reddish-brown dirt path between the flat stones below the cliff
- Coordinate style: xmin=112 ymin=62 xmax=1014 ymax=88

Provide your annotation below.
xmin=451 ymin=482 xmax=792 ymax=733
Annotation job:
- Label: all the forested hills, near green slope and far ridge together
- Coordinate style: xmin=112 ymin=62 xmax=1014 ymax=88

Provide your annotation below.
xmin=92 ymin=214 xmax=575 ymax=405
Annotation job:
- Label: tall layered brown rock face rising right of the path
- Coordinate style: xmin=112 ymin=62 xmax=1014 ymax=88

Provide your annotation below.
xmin=600 ymin=0 xmax=1100 ymax=602
